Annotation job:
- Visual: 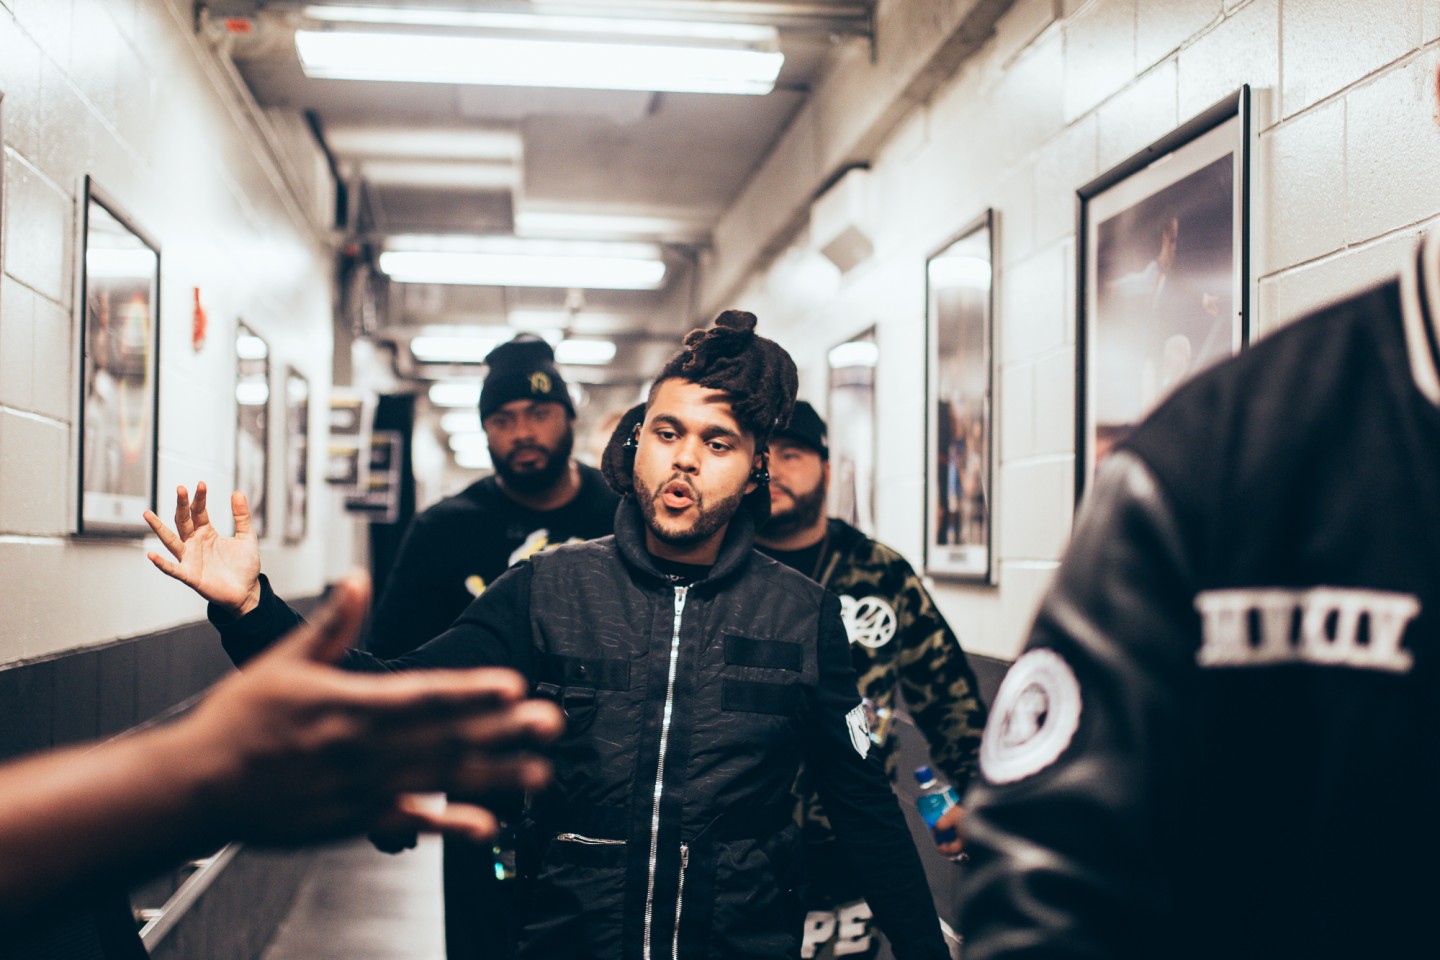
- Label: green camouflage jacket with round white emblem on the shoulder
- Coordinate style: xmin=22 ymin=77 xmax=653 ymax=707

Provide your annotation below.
xmin=796 ymin=518 xmax=985 ymax=843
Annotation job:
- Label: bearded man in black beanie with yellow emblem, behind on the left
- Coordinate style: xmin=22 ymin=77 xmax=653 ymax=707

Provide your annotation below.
xmin=367 ymin=334 xmax=619 ymax=960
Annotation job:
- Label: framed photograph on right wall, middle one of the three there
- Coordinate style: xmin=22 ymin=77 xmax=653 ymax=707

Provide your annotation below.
xmin=924 ymin=210 xmax=995 ymax=583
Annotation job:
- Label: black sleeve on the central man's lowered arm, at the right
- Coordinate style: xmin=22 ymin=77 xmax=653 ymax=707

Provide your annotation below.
xmin=805 ymin=593 xmax=950 ymax=960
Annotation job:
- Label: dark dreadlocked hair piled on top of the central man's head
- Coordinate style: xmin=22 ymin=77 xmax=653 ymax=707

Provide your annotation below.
xmin=651 ymin=309 xmax=799 ymax=450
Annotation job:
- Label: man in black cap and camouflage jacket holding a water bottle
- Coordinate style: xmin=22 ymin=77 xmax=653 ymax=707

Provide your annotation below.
xmin=755 ymin=400 xmax=985 ymax=957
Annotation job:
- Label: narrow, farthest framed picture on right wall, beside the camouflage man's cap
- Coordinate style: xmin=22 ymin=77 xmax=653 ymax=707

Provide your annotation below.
xmin=825 ymin=327 xmax=880 ymax=535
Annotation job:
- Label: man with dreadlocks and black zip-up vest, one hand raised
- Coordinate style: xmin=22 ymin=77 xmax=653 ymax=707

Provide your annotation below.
xmin=140 ymin=311 xmax=949 ymax=960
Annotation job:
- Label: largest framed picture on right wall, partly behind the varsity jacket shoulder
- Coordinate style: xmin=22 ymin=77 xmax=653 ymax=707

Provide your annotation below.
xmin=1076 ymin=86 xmax=1250 ymax=499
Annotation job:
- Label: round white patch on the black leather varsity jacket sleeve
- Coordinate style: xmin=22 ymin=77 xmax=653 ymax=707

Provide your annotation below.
xmin=981 ymin=649 xmax=1080 ymax=783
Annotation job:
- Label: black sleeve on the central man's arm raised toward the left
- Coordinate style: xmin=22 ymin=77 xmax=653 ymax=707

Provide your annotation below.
xmin=210 ymin=561 xmax=531 ymax=676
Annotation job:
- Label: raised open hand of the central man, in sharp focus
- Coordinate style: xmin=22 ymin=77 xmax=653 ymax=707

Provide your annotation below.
xmin=144 ymin=481 xmax=261 ymax=615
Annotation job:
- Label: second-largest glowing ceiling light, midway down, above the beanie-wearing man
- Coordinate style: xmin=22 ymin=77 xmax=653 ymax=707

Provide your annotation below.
xmin=380 ymin=237 xmax=665 ymax=289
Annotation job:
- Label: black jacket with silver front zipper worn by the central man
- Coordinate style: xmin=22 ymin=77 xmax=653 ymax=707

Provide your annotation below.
xmin=213 ymin=501 xmax=948 ymax=960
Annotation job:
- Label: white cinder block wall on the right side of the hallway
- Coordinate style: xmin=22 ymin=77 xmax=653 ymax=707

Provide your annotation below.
xmin=714 ymin=0 xmax=1440 ymax=658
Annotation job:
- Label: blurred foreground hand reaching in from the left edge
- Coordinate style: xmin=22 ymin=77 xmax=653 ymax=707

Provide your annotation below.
xmin=177 ymin=577 xmax=562 ymax=846
